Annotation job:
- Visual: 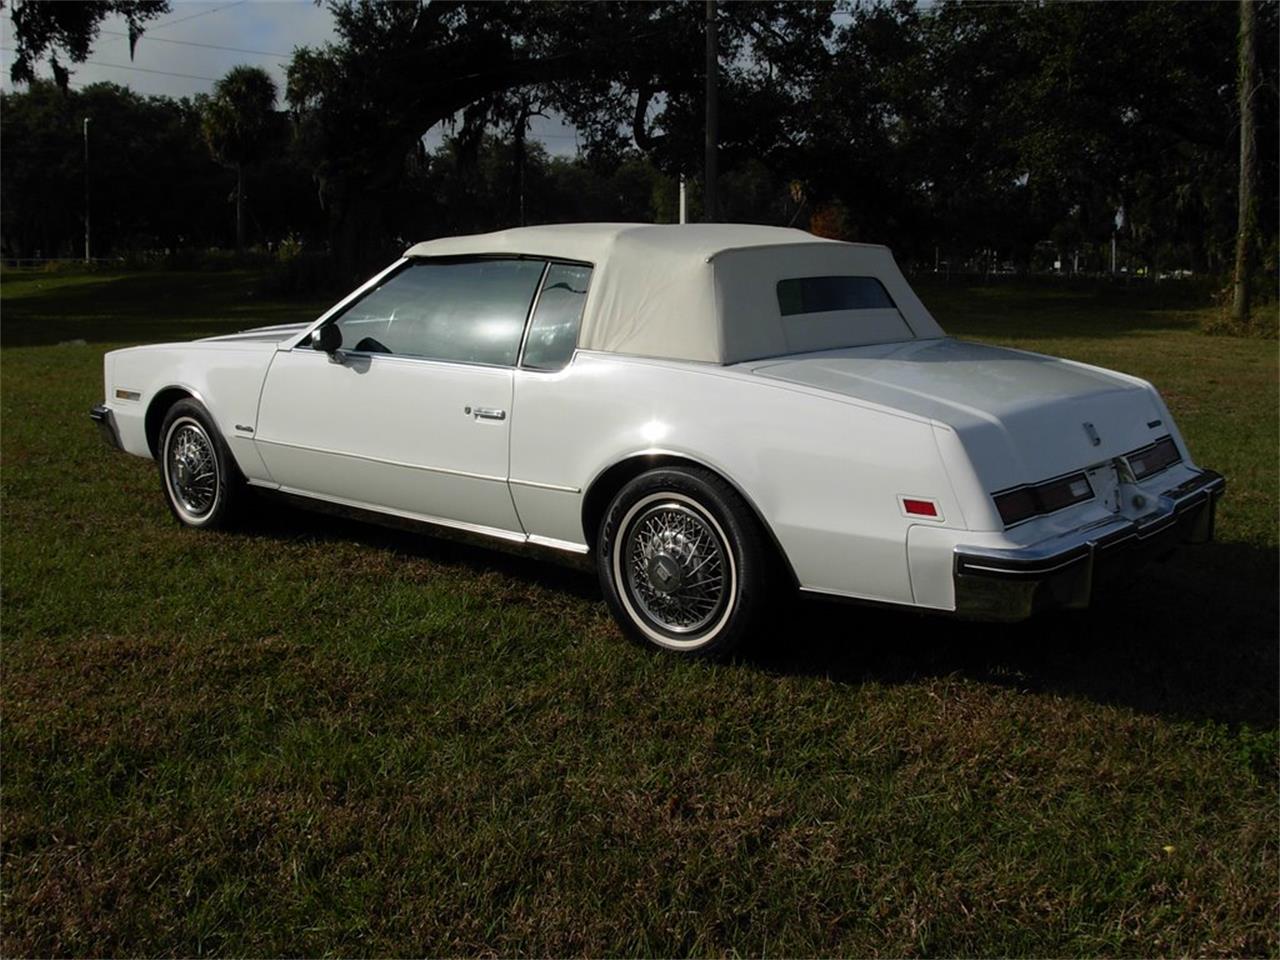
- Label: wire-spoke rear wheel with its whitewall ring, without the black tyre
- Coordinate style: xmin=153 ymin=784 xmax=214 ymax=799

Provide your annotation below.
xmin=614 ymin=494 xmax=736 ymax=643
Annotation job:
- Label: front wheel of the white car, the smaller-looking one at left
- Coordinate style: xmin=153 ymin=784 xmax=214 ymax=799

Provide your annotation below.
xmin=159 ymin=399 xmax=243 ymax=529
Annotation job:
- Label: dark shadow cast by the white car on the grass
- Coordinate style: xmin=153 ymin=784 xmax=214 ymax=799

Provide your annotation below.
xmin=251 ymin=497 xmax=1280 ymax=730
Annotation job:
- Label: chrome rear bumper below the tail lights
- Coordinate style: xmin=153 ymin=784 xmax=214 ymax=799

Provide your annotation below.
xmin=954 ymin=470 xmax=1226 ymax=621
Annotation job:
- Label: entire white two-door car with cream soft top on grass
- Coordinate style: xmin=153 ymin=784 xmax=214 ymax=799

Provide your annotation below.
xmin=92 ymin=224 xmax=1224 ymax=654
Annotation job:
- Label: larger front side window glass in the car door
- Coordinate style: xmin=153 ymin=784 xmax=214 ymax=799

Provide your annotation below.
xmin=335 ymin=260 xmax=545 ymax=366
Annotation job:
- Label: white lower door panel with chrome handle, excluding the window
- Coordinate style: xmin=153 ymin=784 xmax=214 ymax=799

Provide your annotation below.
xmin=255 ymin=348 xmax=520 ymax=534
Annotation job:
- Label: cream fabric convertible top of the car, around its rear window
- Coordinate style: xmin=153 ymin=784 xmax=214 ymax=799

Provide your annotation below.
xmin=404 ymin=224 xmax=943 ymax=364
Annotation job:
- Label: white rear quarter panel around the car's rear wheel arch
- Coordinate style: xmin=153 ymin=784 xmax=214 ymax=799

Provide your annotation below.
xmin=511 ymin=352 xmax=960 ymax=603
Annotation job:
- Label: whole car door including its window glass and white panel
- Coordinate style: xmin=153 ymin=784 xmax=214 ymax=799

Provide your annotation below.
xmin=256 ymin=257 xmax=545 ymax=538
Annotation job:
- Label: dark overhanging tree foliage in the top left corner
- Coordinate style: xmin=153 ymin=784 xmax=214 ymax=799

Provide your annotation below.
xmin=0 ymin=0 xmax=169 ymax=90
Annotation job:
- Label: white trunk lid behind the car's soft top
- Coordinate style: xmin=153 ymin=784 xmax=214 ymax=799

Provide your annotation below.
xmin=751 ymin=338 xmax=1172 ymax=492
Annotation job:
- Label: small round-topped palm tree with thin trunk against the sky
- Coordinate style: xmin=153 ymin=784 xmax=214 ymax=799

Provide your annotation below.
xmin=200 ymin=67 xmax=275 ymax=250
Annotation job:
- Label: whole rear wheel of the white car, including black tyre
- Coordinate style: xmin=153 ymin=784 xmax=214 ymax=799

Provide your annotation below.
xmin=596 ymin=467 xmax=771 ymax=657
